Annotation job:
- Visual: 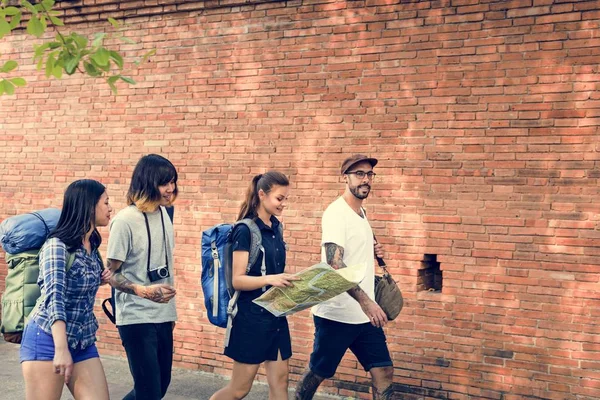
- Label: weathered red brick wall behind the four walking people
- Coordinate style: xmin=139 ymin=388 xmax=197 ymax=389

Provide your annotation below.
xmin=0 ymin=0 xmax=600 ymax=399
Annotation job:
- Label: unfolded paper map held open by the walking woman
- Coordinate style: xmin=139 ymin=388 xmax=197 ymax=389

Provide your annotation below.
xmin=254 ymin=263 xmax=365 ymax=317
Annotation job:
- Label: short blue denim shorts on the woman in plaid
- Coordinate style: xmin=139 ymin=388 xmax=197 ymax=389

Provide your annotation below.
xmin=19 ymin=321 xmax=100 ymax=364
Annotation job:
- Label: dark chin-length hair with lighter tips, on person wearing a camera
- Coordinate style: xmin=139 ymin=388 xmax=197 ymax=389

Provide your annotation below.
xmin=127 ymin=154 xmax=179 ymax=212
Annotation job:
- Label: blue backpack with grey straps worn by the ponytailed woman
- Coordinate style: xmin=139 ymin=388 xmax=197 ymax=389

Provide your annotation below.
xmin=201 ymin=218 xmax=283 ymax=347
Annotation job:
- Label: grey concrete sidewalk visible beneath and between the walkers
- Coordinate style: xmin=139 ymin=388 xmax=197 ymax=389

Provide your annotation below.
xmin=0 ymin=336 xmax=335 ymax=400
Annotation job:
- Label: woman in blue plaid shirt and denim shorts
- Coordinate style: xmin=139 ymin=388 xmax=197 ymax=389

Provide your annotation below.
xmin=20 ymin=179 xmax=112 ymax=400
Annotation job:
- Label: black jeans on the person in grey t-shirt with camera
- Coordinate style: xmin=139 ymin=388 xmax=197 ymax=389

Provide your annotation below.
xmin=118 ymin=322 xmax=173 ymax=400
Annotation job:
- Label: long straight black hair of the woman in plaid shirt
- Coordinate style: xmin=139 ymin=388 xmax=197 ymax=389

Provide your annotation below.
xmin=49 ymin=179 xmax=106 ymax=251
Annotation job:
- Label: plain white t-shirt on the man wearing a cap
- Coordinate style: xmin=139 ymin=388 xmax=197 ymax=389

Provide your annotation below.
xmin=312 ymin=197 xmax=375 ymax=324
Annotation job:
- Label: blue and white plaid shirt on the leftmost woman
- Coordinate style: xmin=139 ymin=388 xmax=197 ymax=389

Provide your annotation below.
xmin=31 ymin=238 xmax=102 ymax=349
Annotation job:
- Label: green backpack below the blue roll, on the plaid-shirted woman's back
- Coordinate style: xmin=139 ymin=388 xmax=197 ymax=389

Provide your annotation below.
xmin=0 ymin=249 xmax=75 ymax=343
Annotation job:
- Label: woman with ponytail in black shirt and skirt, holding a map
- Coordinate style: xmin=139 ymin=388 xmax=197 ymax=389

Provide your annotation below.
xmin=211 ymin=171 xmax=297 ymax=400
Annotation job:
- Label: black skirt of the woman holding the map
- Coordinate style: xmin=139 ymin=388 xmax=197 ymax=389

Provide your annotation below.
xmin=224 ymin=301 xmax=292 ymax=364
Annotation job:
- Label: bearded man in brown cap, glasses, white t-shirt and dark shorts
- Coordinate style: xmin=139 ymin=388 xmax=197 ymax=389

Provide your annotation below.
xmin=296 ymin=154 xmax=394 ymax=400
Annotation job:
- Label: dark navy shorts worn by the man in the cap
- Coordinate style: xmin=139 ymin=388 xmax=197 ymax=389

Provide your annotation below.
xmin=309 ymin=315 xmax=393 ymax=379
